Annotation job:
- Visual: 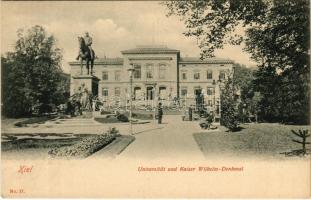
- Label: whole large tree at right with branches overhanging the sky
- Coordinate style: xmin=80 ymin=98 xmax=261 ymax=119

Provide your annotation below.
xmin=162 ymin=0 xmax=310 ymax=122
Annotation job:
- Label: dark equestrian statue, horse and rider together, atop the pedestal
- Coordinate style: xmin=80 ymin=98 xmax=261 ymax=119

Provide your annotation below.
xmin=76 ymin=32 xmax=95 ymax=75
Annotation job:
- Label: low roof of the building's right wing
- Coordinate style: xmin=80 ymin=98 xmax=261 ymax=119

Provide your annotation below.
xmin=179 ymin=57 xmax=233 ymax=64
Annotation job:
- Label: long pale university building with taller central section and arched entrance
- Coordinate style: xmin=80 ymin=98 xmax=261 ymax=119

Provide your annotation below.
xmin=69 ymin=46 xmax=233 ymax=111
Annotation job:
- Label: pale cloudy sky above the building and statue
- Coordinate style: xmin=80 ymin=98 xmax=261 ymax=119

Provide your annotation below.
xmin=1 ymin=1 xmax=255 ymax=72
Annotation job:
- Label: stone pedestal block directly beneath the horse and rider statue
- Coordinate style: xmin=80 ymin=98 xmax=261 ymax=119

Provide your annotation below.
xmin=70 ymin=75 xmax=99 ymax=96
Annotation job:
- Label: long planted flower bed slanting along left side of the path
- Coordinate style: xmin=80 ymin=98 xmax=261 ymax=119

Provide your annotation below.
xmin=48 ymin=128 xmax=118 ymax=158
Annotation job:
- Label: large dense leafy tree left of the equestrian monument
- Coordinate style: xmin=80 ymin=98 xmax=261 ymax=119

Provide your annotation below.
xmin=1 ymin=25 xmax=62 ymax=117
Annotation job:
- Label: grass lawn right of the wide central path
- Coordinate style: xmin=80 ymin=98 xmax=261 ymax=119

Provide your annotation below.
xmin=193 ymin=123 xmax=310 ymax=158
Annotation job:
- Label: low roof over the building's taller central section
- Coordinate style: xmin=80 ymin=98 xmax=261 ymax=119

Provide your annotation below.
xmin=121 ymin=45 xmax=180 ymax=54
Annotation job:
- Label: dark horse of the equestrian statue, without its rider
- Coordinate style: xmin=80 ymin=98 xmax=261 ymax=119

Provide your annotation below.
xmin=77 ymin=37 xmax=95 ymax=75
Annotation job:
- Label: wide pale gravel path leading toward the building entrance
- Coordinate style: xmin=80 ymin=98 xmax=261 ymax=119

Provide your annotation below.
xmin=117 ymin=115 xmax=207 ymax=160
